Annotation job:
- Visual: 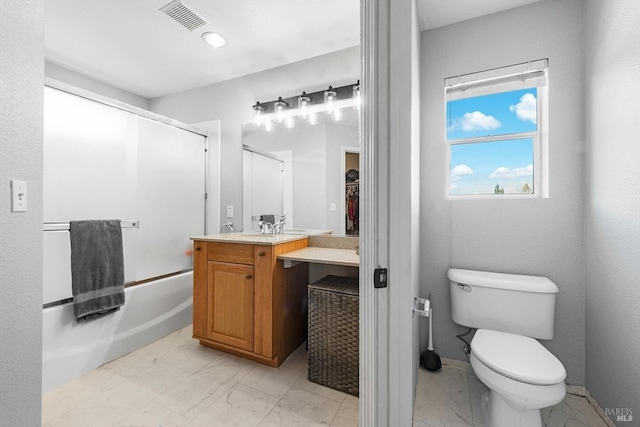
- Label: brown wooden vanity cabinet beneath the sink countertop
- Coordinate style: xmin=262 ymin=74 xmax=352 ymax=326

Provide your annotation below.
xmin=193 ymin=239 xmax=309 ymax=366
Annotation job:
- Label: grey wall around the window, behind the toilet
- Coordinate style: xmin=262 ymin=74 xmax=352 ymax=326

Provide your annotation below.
xmin=421 ymin=0 xmax=585 ymax=384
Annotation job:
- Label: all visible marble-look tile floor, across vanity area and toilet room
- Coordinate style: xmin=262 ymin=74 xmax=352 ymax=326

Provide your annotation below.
xmin=42 ymin=326 xmax=606 ymax=427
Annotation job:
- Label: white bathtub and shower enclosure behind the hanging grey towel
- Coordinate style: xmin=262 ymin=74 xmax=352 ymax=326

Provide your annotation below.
xmin=42 ymin=82 xmax=216 ymax=392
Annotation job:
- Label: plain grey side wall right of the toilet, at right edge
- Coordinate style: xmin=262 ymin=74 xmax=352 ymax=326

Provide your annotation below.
xmin=585 ymin=0 xmax=640 ymax=416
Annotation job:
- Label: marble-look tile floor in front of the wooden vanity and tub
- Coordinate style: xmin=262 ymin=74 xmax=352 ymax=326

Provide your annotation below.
xmin=42 ymin=326 xmax=358 ymax=427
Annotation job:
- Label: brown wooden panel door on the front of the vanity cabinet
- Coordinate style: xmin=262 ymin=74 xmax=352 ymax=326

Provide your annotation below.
xmin=207 ymin=261 xmax=254 ymax=351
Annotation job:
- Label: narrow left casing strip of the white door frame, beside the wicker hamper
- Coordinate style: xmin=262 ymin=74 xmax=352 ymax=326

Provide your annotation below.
xmin=359 ymin=0 xmax=389 ymax=427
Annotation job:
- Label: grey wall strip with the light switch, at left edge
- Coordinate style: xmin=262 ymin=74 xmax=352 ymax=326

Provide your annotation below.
xmin=0 ymin=0 xmax=44 ymax=426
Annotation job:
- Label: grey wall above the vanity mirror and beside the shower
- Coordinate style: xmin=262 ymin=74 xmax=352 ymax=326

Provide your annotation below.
xmin=149 ymin=46 xmax=360 ymax=229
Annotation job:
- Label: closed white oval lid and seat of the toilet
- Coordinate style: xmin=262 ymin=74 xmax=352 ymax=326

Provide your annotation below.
xmin=471 ymin=329 xmax=567 ymax=385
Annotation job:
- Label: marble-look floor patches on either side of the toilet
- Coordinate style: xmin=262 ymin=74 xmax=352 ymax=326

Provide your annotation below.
xmin=413 ymin=361 xmax=612 ymax=427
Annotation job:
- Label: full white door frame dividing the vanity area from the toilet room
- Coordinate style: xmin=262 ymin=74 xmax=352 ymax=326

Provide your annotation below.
xmin=360 ymin=0 xmax=420 ymax=427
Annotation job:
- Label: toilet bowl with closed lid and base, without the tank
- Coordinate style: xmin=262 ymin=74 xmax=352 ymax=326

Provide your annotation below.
xmin=470 ymin=329 xmax=567 ymax=427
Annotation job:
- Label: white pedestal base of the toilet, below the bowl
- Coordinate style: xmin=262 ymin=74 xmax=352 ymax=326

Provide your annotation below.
xmin=481 ymin=390 xmax=542 ymax=427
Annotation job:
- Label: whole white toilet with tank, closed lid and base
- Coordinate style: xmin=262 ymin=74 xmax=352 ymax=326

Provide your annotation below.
xmin=447 ymin=268 xmax=567 ymax=427
